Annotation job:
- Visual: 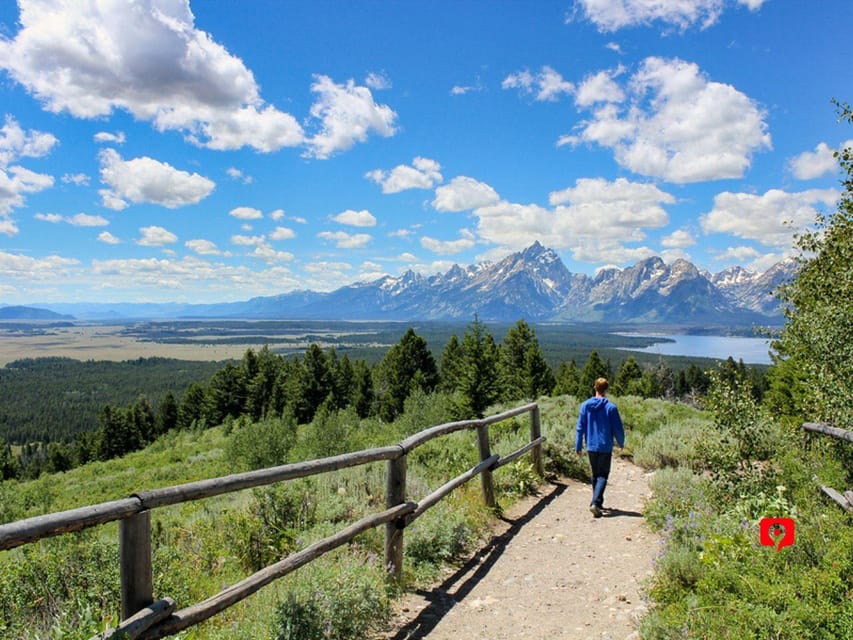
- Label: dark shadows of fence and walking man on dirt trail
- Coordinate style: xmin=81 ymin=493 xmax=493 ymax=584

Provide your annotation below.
xmin=389 ymin=481 xmax=564 ymax=640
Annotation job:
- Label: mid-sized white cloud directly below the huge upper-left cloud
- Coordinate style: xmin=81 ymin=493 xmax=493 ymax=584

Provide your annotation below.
xmin=98 ymin=149 xmax=216 ymax=211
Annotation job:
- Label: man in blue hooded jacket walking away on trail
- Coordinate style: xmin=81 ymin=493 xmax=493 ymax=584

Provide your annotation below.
xmin=575 ymin=378 xmax=625 ymax=518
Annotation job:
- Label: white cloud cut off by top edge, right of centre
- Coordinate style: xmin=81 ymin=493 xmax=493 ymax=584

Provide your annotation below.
xmin=570 ymin=0 xmax=766 ymax=32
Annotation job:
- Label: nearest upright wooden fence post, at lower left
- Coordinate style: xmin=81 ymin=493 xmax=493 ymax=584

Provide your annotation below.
xmin=118 ymin=510 xmax=154 ymax=620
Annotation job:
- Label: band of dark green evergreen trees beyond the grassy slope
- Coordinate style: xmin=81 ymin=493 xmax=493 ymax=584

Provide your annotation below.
xmin=0 ymin=318 xmax=764 ymax=479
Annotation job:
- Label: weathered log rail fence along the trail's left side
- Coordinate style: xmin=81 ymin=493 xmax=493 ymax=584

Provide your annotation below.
xmin=0 ymin=403 xmax=545 ymax=640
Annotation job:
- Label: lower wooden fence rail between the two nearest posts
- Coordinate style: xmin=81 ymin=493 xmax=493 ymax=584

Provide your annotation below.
xmin=139 ymin=502 xmax=417 ymax=640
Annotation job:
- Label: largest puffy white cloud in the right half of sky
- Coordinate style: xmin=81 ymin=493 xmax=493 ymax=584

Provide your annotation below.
xmin=558 ymin=58 xmax=771 ymax=183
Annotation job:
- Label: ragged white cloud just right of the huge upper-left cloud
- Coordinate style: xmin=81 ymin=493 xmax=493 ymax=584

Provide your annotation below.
xmin=307 ymin=75 xmax=397 ymax=159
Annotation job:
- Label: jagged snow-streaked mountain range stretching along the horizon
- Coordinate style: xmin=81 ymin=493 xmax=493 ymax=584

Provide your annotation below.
xmin=18 ymin=242 xmax=796 ymax=325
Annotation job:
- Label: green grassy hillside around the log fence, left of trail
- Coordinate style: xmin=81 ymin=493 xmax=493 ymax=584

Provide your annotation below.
xmin=0 ymin=394 xmax=701 ymax=640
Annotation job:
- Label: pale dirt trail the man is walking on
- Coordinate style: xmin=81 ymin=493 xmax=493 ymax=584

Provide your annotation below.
xmin=382 ymin=456 xmax=659 ymax=640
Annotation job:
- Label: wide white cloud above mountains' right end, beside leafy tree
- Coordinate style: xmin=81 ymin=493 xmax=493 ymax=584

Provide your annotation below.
xmin=699 ymin=189 xmax=839 ymax=247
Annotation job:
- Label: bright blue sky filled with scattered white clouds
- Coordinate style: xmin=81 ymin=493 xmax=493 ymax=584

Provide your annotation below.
xmin=0 ymin=0 xmax=853 ymax=304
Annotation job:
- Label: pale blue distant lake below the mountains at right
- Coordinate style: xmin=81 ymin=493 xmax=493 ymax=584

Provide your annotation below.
xmin=619 ymin=333 xmax=770 ymax=364
